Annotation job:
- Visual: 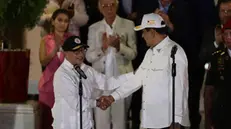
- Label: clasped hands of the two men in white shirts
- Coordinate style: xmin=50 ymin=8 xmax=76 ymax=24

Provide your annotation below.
xmin=96 ymin=95 xmax=115 ymax=110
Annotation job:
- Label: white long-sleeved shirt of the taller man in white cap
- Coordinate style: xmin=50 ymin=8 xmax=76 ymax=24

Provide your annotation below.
xmin=111 ymin=37 xmax=189 ymax=128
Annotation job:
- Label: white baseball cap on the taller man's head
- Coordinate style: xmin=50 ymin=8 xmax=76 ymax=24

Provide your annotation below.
xmin=134 ymin=13 xmax=166 ymax=31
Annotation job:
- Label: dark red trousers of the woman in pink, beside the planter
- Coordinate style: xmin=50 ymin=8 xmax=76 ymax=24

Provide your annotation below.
xmin=39 ymin=102 xmax=53 ymax=129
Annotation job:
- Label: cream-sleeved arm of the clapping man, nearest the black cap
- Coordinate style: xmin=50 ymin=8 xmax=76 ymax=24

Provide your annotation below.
xmin=86 ymin=26 xmax=104 ymax=63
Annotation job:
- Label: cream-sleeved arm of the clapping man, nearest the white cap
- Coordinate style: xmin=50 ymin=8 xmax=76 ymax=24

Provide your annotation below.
xmin=119 ymin=21 xmax=137 ymax=60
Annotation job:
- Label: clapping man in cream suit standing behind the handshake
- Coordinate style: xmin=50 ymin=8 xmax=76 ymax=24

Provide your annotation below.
xmin=86 ymin=0 xmax=137 ymax=129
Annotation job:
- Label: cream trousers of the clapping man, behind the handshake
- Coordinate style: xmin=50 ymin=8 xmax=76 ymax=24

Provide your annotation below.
xmin=94 ymin=99 xmax=128 ymax=129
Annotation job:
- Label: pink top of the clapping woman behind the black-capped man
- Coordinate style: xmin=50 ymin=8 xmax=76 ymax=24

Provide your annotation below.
xmin=38 ymin=33 xmax=71 ymax=108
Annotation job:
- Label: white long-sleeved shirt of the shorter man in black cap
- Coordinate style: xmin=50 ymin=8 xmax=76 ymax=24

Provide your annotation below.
xmin=52 ymin=59 xmax=133 ymax=129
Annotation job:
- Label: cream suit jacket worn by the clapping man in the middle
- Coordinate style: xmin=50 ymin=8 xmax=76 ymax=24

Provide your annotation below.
xmin=86 ymin=16 xmax=137 ymax=74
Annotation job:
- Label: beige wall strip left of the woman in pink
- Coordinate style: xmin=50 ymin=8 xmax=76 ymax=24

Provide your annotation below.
xmin=24 ymin=27 xmax=41 ymax=81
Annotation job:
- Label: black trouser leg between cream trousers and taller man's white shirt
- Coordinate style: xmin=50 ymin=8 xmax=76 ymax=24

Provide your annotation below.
xmin=131 ymin=88 xmax=142 ymax=129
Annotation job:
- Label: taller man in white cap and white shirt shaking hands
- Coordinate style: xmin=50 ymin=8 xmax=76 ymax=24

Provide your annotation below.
xmin=97 ymin=13 xmax=189 ymax=129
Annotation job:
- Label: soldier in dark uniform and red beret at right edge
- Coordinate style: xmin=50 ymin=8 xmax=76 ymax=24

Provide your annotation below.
xmin=205 ymin=20 xmax=231 ymax=129
